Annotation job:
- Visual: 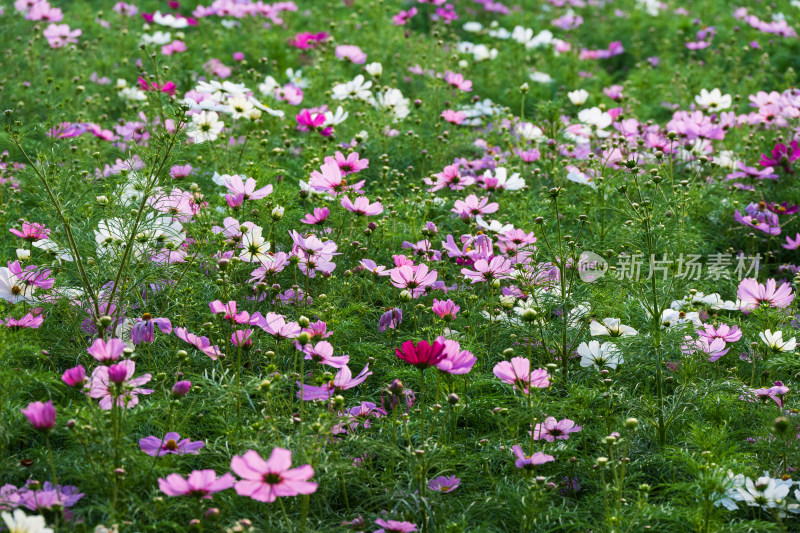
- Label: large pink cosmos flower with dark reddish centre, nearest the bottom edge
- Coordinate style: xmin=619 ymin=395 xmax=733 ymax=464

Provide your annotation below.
xmin=231 ymin=448 xmax=317 ymax=503
